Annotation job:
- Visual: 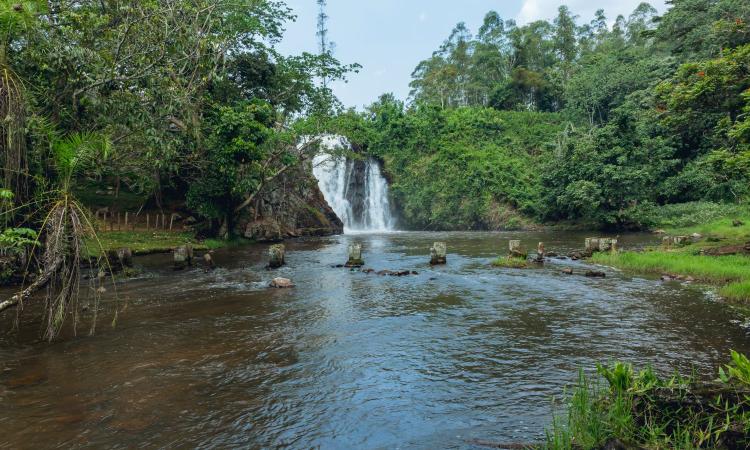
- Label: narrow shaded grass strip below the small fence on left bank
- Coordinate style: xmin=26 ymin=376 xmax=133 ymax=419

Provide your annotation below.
xmin=89 ymin=231 xmax=251 ymax=255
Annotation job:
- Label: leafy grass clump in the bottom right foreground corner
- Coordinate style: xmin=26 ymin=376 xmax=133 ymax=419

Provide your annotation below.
xmin=542 ymin=352 xmax=750 ymax=450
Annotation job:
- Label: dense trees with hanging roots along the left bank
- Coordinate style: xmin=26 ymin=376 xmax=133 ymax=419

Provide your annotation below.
xmin=0 ymin=0 xmax=357 ymax=339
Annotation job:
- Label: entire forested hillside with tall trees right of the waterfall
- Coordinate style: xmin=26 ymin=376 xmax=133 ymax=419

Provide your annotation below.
xmin=336 ymin=0 xmax=750 ymax=229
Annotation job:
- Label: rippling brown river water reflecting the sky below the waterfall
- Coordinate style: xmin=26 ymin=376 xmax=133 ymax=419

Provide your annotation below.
xmin=0 ymin=233 xmax=750 ymax=449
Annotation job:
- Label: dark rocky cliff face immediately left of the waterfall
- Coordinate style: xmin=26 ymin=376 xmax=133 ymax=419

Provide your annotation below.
xmin=234 ymin=163 xmax=344 ymax=242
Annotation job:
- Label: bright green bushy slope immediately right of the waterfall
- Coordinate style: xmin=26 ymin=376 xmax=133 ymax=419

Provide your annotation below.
xmin=336 ymin=102 xmax=562 ymax=229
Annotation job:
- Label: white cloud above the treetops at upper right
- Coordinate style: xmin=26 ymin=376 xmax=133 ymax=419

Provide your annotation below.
xmin=516 ymin=0 xmax=666 ymax=25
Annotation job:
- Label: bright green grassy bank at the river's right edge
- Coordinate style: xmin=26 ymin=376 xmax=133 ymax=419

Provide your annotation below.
xmin=592 ymin=215 xmax=750 ymax=304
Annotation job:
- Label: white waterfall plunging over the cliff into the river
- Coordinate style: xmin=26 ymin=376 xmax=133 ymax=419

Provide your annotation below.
xmin=313 ymin=136 xmax=394 ymax=232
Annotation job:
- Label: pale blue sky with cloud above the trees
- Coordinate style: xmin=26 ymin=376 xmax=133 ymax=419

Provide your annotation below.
xmin=278 ymin=0 xmax=666 ymax=108
